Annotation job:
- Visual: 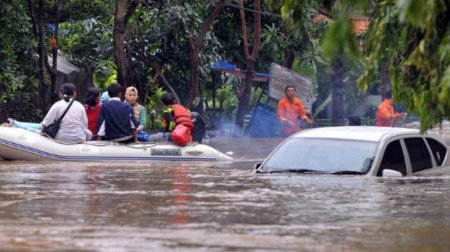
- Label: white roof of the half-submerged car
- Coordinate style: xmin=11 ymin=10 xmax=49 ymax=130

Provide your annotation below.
xmin=292 ymin=126 xmax=420 ymax=142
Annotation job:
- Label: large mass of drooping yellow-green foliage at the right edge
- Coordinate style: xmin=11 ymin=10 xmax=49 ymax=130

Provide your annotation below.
xmin=359 ymin=0 xmax=450 ymax=130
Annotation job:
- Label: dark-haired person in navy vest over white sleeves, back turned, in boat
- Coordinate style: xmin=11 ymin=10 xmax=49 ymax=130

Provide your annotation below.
xmin=97 ymin=83 xmax=139 ymax=143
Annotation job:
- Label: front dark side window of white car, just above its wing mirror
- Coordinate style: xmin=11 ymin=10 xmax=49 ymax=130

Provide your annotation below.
xmin=377 ymin=140 xmax=406 ymax=177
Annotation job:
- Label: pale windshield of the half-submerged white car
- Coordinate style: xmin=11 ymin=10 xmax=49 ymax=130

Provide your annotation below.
xmin=261 ymin=138 xmax=377 ymax=174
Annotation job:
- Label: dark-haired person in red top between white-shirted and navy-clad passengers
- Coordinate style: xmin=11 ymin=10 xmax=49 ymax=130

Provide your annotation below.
xmin=84 ymin=87 xmax=101 ymax=140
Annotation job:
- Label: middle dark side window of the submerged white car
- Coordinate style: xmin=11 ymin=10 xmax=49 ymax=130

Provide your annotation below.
xmin=405 ymin=137 xmax=432 ymax=172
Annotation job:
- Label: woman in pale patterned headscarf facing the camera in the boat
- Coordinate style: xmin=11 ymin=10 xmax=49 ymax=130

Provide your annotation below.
xmin=125 ymin=87 xmax=148 ymax=142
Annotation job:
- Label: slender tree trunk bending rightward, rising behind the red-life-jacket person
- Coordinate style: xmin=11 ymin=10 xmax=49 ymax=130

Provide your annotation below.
xmin=184 ymin=0 xmax=225 ymax=107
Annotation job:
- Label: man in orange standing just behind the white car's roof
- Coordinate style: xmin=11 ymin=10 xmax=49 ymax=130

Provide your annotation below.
xmin=277 ymin=85 xmax=312 ymax=137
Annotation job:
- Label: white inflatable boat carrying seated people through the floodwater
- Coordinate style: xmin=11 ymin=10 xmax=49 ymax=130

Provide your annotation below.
xmin=0 ymin=126 xmax=232 ymax=161
